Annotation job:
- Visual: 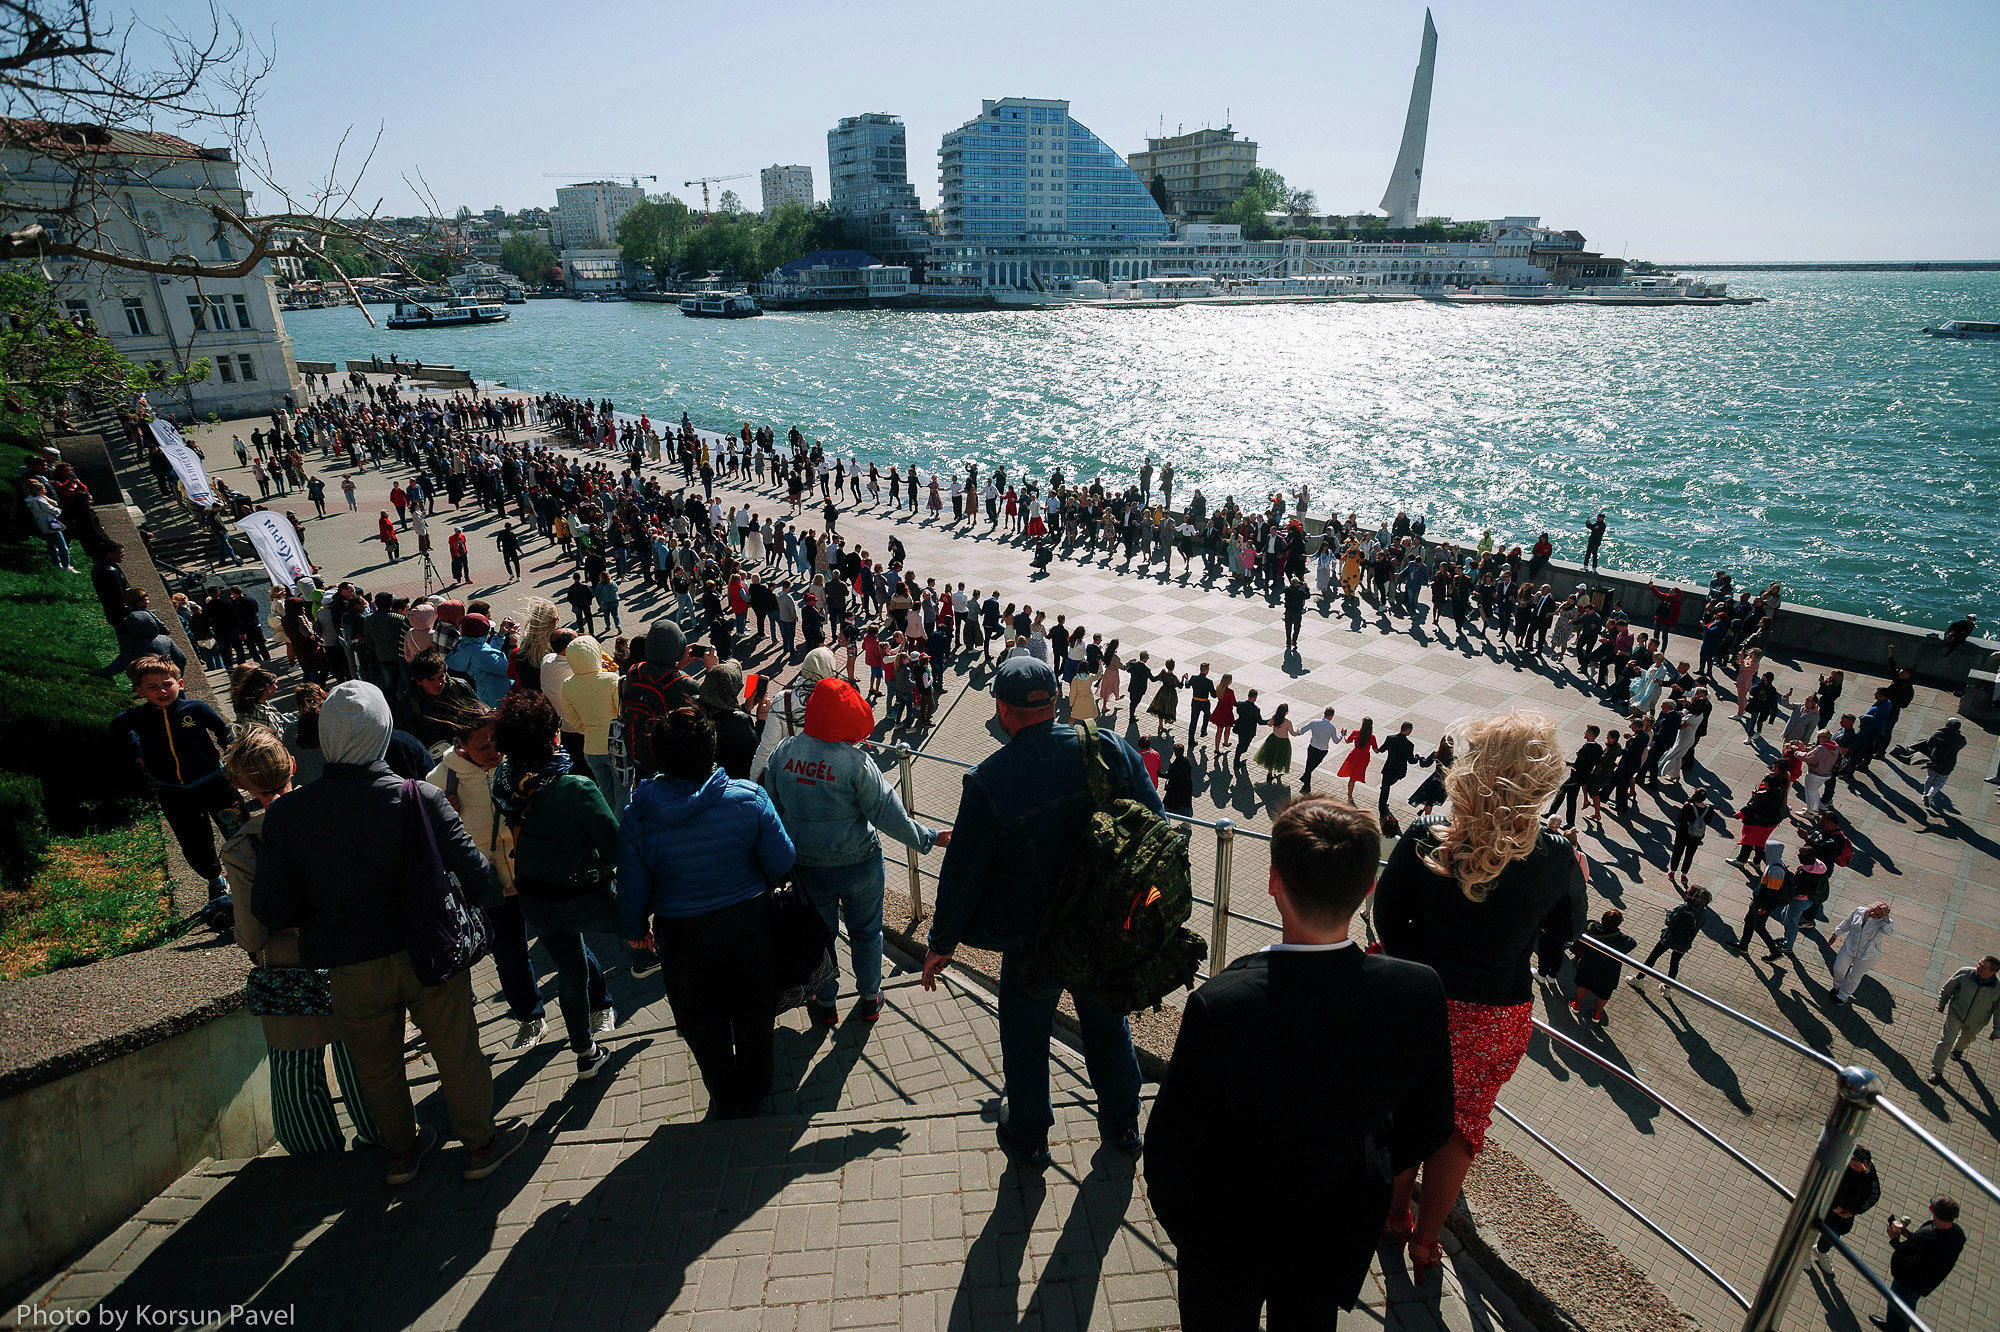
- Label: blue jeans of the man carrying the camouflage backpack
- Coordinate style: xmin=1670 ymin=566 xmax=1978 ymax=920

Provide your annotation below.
xmin=1000 ymin=950 xmax=1140 ymax=1142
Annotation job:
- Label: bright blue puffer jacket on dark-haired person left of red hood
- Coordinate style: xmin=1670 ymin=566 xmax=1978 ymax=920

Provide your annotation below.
xmin=618 ymin=768 xmax=796 ymax=940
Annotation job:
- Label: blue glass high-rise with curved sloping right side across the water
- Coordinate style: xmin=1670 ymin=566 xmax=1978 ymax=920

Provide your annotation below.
xmin=932 ymin=98 xmax=1172 ymax=288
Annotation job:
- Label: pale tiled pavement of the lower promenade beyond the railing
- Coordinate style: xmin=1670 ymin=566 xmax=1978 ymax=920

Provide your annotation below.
xmin=125 ymin=390 xmax=2000 ymax=1326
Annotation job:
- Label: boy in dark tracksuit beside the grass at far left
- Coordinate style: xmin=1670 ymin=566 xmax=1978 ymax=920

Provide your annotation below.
xmin=110 ymin=656 xmax=236 ymax=902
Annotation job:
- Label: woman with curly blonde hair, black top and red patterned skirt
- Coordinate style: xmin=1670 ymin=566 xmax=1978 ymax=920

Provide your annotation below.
xmin=1374 ymin=712 xmax=1588 ymax=1278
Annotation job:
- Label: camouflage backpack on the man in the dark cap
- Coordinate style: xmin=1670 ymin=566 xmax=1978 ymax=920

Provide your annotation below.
xmin=1034 ymin=722 xmax=1208 ymax=1014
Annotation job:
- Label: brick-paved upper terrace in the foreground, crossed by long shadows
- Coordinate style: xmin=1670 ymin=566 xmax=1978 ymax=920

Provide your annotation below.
xmin=6 ymin=944 xmax=1530 ymax=1332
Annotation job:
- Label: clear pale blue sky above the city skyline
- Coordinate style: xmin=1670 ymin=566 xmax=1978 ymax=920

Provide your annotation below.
xmin=146 ymin=0 xmax=2000 ymax=260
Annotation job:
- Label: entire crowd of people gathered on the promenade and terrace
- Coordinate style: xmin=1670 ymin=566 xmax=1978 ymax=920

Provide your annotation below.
xmin=70 ymin=380 xmax=1976 ymax=1326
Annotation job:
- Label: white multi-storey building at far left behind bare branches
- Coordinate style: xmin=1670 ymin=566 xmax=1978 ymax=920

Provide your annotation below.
xmin=0 ymin=120 xmax=298 ymax=418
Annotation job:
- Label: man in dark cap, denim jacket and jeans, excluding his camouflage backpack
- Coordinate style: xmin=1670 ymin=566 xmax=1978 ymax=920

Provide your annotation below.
xmin=924 ymin=656 xmax=1160 ymax=1164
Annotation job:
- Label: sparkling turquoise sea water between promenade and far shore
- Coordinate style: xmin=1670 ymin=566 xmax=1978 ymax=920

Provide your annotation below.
xmin=286 ymin=272 xmax=2000 ymax=628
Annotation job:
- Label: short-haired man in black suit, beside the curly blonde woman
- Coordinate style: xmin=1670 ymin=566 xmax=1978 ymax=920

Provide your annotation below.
xmin=1146 ymin=796 xmax=1452 ymax=1332
